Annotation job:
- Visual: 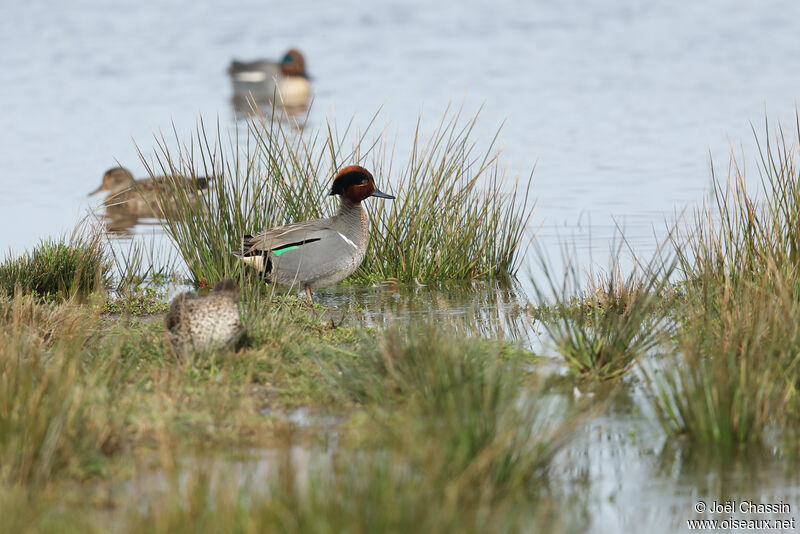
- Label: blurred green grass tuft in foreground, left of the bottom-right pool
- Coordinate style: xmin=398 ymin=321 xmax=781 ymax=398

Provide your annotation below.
xmin=323 ymin=327 xmax=574 ymax=500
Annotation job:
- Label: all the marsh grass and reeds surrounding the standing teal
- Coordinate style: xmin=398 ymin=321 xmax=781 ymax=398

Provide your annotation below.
xmin=0 ymin=113 xmax=800 ymax=532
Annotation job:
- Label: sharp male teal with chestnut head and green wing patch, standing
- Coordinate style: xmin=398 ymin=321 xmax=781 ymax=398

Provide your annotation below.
xmin=234 ymin=165 xmax=394 ymax=300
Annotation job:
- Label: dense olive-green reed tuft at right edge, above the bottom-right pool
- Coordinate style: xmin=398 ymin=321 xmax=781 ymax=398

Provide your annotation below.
xmin=645 ymin=266 xmax=800 ymax=451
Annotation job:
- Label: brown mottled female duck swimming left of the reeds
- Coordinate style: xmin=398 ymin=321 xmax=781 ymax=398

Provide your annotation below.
xmin=89 ymin=167 xmax=208 ymax=217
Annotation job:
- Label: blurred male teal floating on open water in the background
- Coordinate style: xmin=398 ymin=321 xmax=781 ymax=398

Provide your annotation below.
xmin=228 ymin=48 xmax=311 ymax=108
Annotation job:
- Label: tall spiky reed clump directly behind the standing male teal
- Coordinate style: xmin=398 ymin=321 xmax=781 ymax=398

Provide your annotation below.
xmin=142 ymin=105 xmax=533 ymax=283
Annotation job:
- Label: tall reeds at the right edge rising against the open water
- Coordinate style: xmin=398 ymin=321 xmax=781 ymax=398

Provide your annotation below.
xmin=674 ymin=117 xmax=800 ymax=303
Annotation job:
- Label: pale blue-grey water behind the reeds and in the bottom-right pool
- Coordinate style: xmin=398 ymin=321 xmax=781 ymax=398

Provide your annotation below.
xmin=0 ymin=0 xmax=800 ymax=532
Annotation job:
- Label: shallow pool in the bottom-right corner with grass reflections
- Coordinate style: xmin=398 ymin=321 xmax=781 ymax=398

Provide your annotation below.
xmin=550 ymin=376 xmax=800 ymax=533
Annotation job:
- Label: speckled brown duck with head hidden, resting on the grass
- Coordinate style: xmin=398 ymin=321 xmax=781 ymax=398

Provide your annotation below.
xmin=165 ymin=278 xmax=244 ymax=354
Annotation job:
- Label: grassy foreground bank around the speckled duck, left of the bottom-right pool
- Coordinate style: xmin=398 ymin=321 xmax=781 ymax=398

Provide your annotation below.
xmin=0 ymin=286 xmax=581 ymax=532
